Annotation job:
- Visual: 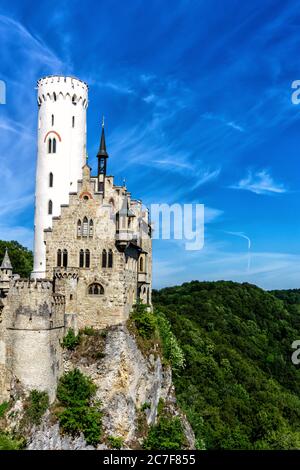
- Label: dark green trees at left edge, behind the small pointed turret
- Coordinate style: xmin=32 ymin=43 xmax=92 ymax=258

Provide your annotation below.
xmin=0 ymin=240 xmax=33 ymax=277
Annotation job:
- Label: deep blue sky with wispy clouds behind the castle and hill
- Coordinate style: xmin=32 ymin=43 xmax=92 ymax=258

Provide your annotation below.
xmin=0 ymin=0 xmax=300 ymax=289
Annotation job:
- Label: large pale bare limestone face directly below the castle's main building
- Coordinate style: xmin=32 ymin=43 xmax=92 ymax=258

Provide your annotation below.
xmin=65 ymin=325 xmax=195 ymax=448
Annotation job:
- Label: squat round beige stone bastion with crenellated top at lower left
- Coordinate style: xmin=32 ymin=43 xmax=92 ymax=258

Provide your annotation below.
xmin=2 ymin=280 xmax=65 ymax=401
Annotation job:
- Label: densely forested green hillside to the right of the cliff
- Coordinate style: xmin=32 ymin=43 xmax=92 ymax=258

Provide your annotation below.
xmin=153 ymin=281 xmax=300 ymax=449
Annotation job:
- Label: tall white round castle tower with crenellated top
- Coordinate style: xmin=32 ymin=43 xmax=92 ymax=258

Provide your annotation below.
xmin=32 ymin=76 xmax=88 ymax=278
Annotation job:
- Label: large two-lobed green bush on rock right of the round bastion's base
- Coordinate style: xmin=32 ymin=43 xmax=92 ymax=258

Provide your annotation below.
xmin=57 ymin=369 xmax=102 ymax=445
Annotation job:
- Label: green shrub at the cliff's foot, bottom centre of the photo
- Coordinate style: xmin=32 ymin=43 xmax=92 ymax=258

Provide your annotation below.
xmin=143 ymin=415 xmax=185 ymax=450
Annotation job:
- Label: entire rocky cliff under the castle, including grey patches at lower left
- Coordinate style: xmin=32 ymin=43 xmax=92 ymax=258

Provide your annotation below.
xmin=0 ymin=325 xmax=195 ymax=450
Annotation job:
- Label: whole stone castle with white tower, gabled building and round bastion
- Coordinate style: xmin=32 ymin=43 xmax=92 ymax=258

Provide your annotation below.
xmin=0 ymin=76 xmax=152 ymax=401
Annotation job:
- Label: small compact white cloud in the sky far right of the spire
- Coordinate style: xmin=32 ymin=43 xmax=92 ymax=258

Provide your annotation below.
xmin=230 ymin=170 xmax=288 ymax=194
